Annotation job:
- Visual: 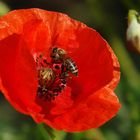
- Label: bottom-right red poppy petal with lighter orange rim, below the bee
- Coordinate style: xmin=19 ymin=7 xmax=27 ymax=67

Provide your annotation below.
xmin=41 ymin=88 xmax=120 ymax=132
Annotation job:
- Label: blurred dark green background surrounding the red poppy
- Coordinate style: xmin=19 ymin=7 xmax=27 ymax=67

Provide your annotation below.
xmin=0 ymin=0 xmax=140 ymax=140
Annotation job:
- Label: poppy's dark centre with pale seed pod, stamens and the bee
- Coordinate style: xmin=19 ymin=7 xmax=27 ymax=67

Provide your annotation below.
xmin=35 ymin=48 xmax=78 ymax=101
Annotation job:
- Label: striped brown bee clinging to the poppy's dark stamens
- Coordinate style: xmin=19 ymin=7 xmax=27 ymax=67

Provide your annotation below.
xmin=50 ymin=47 xmax=78 ymax=77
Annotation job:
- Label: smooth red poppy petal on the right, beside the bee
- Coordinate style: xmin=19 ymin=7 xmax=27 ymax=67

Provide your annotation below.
xmin=70 ymin=27 xmax=120 ymax=98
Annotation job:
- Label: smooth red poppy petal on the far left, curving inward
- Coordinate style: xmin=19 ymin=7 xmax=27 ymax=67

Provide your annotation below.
xmin=0 ymin=35 xmax=40 ymax=114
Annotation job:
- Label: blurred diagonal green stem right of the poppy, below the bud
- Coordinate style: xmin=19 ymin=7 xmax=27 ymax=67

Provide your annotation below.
xmin=112 ymin=37 xmax=140 ymax=91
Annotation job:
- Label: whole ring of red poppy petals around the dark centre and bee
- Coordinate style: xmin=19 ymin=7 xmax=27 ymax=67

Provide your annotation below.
xmin=0 ymin=9 xmax=120 ymax=132
